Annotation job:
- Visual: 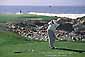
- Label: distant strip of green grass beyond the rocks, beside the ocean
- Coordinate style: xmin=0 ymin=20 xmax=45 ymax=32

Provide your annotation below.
xmin=0 ymin=14 xmax=54 ymax=22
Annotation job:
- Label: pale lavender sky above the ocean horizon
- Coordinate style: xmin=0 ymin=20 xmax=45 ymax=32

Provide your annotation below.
xmin=0 ymin=0 xmax=85 ymax=6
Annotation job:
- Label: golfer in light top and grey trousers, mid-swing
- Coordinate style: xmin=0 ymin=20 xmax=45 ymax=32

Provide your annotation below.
xmin=47 ymin=18 xmax=60 ymax=49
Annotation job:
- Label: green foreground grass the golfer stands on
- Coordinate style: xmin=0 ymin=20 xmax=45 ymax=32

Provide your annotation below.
xmin=0 ymin=32 xmax=85 ymax=57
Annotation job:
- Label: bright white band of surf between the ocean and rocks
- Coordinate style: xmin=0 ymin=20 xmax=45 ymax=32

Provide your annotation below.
xmin=27 ymin=12 xmax=85 ymax=19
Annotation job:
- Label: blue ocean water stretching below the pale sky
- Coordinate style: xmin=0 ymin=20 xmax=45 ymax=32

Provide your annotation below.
xmin=0 ymin=6 xmax=85 ymax=14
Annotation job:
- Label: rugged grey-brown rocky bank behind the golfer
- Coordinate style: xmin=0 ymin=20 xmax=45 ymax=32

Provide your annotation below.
xmin=7 ymin=16 xmax=85 ymax=41
